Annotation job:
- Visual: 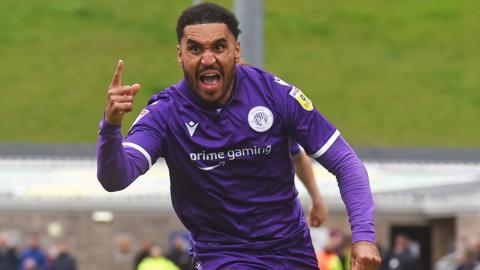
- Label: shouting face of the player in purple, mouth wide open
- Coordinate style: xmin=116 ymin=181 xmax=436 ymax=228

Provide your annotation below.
xmin=177 ymin=23 xmax=240 ymax=104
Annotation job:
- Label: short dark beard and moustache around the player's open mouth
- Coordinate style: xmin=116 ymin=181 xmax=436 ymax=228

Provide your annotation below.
xmin=182 ymin=58 xmax=236 ymax=104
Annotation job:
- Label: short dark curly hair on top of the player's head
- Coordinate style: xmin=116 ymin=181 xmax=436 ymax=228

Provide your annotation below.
xmin=177 ymin=3 xmax=241 ymax=43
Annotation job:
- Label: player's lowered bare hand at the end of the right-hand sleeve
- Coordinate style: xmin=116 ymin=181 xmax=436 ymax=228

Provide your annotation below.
xmin=350 ymin=241 xmax=382 ymax=270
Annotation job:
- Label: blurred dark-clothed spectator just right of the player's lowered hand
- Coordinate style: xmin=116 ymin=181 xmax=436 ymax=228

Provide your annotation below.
xmin=380 ymin=234 xmax=423 ymax=270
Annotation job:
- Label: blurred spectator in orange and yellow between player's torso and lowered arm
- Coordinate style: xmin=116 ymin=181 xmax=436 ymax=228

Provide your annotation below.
xmin=317 ymin=230 xmax=348 ymax=270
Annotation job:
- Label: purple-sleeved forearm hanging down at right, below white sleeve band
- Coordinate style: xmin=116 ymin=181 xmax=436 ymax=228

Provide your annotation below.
xmin=317 ymin=136 xmax=376 ymax=243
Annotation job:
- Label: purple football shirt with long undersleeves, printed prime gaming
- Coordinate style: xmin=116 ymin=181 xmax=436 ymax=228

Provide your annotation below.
xmin=97 ymin=65 xmax=375 ymax=260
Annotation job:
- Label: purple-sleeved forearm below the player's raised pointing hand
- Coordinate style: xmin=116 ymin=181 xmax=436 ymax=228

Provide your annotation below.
xmin=97 ymin=120 xmax=143 ymax=192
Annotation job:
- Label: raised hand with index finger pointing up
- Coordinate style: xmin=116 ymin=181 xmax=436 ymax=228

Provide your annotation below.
xmin=105 ymin=60 xmax=140 ymax=125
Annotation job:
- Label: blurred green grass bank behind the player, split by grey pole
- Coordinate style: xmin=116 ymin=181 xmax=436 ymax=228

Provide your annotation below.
xmin=0 ymin=0 xmax=480 ymax=147
